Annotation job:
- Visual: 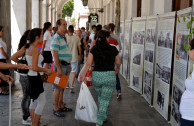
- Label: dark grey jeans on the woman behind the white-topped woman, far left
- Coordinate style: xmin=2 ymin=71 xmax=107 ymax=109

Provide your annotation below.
xmin=20 ymin=75 xmax=30 ymax=120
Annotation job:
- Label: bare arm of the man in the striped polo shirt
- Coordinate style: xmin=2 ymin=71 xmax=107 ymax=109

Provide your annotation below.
xmin=52 ymin=50 xmax=62 ymax=77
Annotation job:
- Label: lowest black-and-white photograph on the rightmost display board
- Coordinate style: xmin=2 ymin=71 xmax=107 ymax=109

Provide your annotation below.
xmin=172 ymin=100 xmax=181 ymax=125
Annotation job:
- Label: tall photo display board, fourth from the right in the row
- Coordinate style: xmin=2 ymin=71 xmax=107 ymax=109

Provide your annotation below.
xmin=130 ymin=17 xmax=146 ymax=94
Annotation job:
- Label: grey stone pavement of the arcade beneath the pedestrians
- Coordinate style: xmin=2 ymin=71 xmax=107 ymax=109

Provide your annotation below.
xmin=0 ymin=74 xmax=170 ymax=126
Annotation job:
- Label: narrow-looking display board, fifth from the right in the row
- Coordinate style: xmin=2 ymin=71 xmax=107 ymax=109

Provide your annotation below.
xmin=123 ymin=20 xmax=131 ymax=82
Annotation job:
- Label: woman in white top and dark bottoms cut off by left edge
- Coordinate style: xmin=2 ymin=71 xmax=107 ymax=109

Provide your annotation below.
xmin=0 ymin=26 xmax=10 ymax=95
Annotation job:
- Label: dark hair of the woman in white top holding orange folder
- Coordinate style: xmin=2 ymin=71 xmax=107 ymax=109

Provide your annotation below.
xmin=26 ymin=28 xmax=42 ymax=48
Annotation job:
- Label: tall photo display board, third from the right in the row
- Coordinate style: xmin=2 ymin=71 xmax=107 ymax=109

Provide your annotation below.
xmin=143 ymin=16 xmax=157 ymax=104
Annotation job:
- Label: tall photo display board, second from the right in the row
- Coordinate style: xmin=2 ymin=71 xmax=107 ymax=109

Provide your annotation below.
xmin=153 ymin=12 xmax=175 ymax=120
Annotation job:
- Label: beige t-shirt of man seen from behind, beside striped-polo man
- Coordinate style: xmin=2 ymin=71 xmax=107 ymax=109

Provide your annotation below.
xmin=66 ymin=35 xmax=81 ymax=62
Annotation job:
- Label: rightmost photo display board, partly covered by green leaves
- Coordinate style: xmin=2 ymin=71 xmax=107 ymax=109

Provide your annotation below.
xmin=171 ymin=8 xmax=192 ymax=126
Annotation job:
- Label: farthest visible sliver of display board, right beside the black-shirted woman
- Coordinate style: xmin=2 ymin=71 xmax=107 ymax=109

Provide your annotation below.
xmin=119 ymin=21 xmax=125 ymax=75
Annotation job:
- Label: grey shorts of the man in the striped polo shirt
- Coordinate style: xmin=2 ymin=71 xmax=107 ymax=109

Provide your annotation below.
xmin=53 ymin=64 xmax=71 ymax=90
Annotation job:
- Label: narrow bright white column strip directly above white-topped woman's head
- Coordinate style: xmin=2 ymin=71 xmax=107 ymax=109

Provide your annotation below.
xmin=32 ymin=0 xmax=40 ymax=28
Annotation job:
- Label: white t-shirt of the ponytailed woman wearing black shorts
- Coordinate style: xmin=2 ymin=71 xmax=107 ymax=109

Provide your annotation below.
xmin=43 ymin=30 xmax=52 ymax=51
